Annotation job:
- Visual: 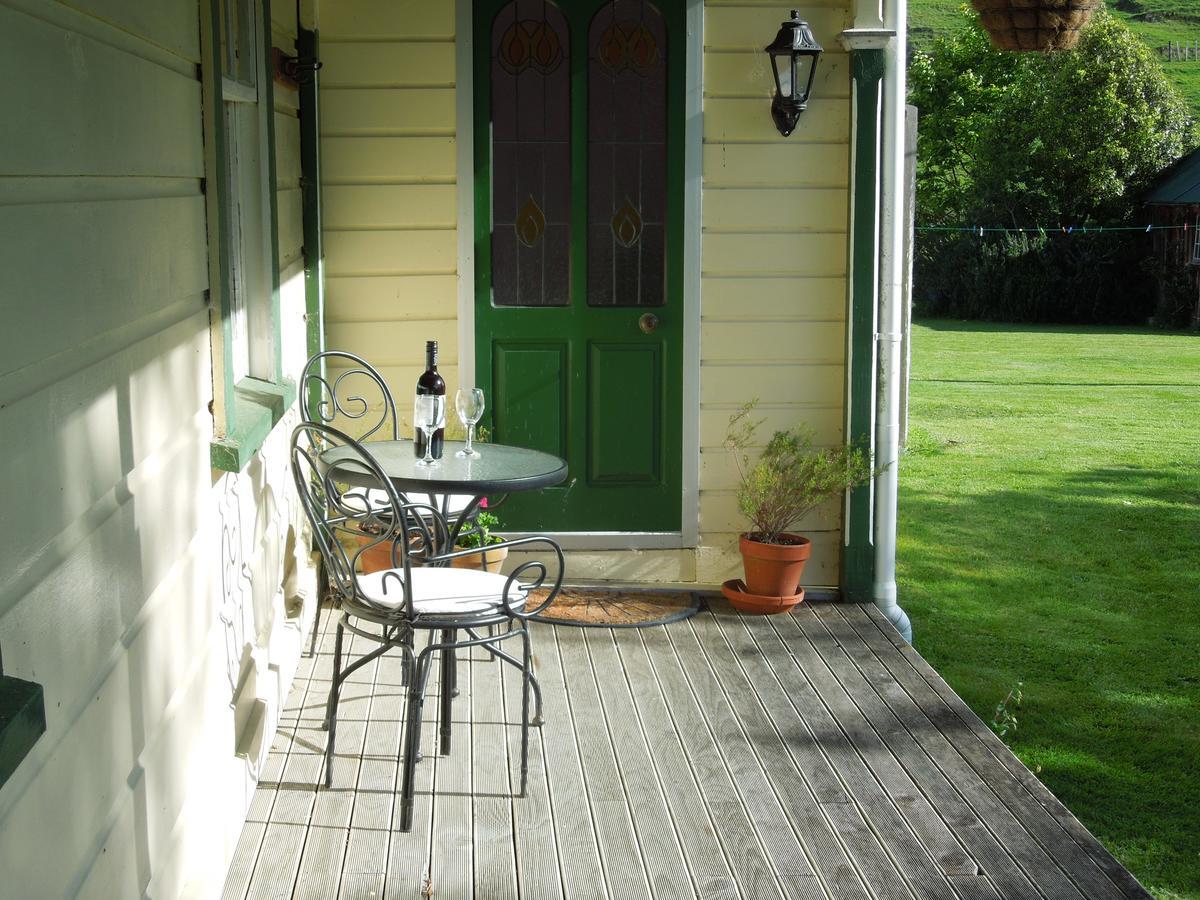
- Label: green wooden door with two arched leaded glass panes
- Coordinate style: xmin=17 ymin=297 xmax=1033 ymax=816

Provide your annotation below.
xmin=474 ymin=0 xmax=685 ymax=532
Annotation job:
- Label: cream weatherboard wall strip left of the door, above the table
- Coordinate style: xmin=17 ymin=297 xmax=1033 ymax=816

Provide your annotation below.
xmin=320 ymin=0 xmax=458 ymax=422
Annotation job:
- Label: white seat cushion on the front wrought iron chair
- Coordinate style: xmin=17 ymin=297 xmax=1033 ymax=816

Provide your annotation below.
xmin=359 ymin=566 xmax=526 ymax=616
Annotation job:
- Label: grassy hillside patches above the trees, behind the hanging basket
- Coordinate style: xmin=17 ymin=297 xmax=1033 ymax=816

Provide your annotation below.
xmin=908 ymin=0 xmax=1200 ymax=115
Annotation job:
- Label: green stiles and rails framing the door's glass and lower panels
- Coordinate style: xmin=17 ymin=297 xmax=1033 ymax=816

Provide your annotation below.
xmin=472 ymin=0 xmax=695 ymax=532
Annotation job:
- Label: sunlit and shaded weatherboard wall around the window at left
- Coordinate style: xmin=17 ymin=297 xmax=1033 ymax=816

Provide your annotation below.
xmin=0 ymin=0 xmax=313 ymax=900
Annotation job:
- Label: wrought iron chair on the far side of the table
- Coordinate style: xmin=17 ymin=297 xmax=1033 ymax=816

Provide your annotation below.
xmin=300 ymin=350 xmax=475 ymax=655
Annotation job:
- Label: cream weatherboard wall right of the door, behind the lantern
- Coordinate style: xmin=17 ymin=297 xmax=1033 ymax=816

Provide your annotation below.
xmin=697 ymin=0 xmax=851 ymax=586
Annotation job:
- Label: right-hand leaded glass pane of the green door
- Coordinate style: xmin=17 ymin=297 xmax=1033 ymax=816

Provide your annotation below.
xmin=588 ymin=0 xmax=667 ymax=306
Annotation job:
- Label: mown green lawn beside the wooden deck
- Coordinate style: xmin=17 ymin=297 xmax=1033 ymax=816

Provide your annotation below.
xmin=899 ymin=320 xmax=1200 ymax=898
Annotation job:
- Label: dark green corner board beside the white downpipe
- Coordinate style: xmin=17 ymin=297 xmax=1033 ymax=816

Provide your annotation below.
xmin=841 ymin=49 xmax=886 ymax=602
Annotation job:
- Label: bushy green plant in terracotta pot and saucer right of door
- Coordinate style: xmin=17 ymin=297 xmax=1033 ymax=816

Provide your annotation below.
xmin=721 ymin=401 xmax=872 ymax=612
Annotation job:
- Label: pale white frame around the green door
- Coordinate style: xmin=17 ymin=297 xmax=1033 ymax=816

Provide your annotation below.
xmin=455 ymin=0 xmax=704 ymax=550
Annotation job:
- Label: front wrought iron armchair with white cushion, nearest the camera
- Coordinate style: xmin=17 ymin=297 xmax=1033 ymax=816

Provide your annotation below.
xmin=292 ymin=422 xmax=563 ymax=832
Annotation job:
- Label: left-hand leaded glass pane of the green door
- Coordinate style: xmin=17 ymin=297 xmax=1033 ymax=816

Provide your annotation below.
xmin=492 ymin=0 xmax=571 ymax=306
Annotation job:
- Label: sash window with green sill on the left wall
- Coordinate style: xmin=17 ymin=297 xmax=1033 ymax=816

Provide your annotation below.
xmin=200 ymin=0 xmax=295 ymax=472
